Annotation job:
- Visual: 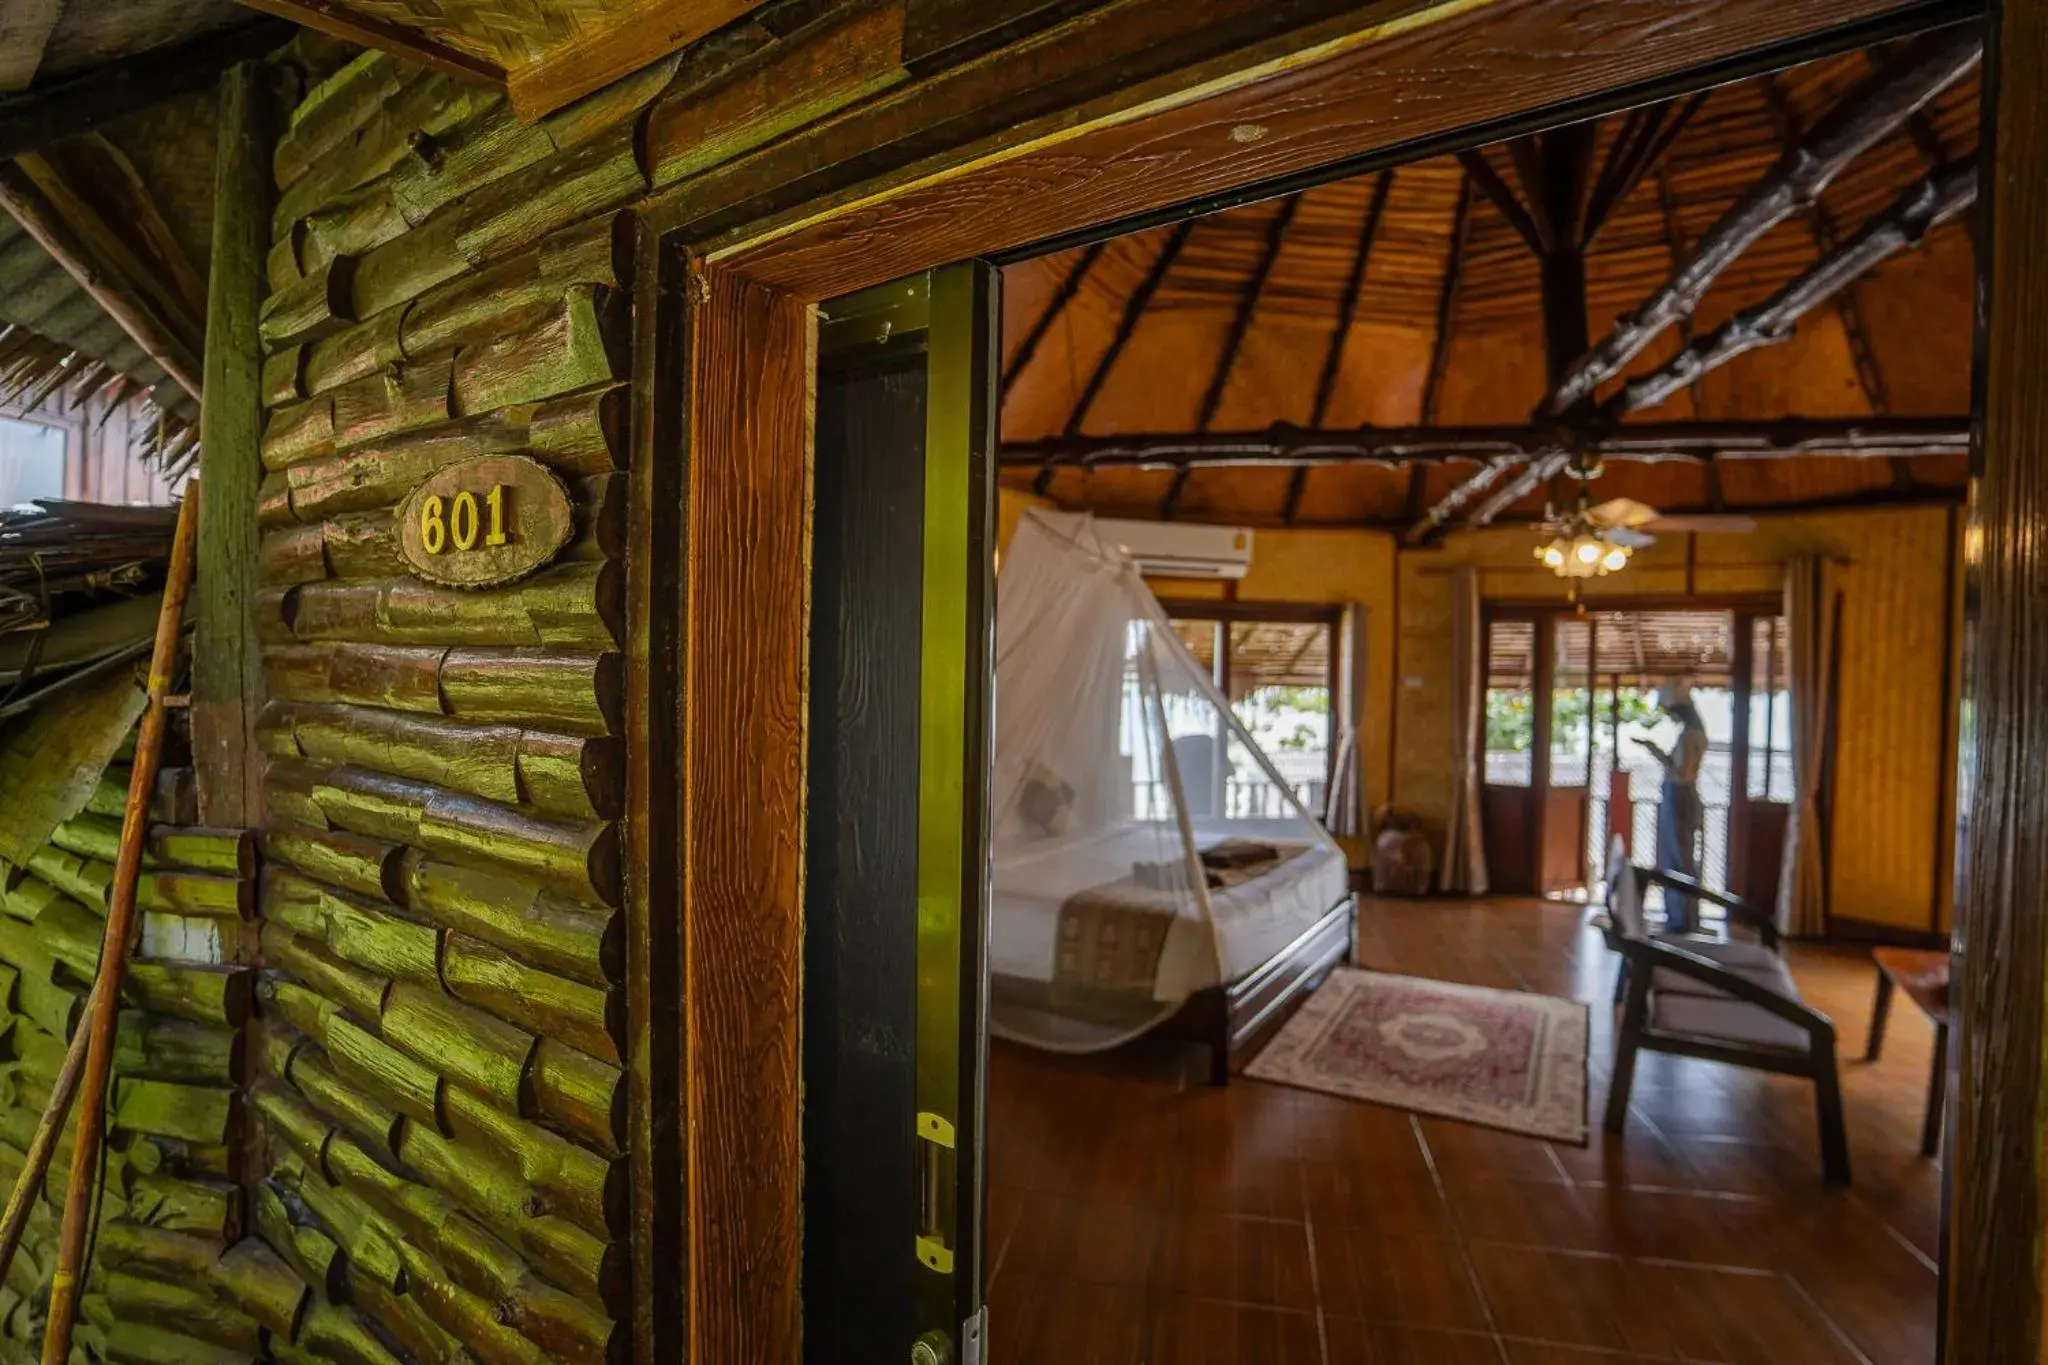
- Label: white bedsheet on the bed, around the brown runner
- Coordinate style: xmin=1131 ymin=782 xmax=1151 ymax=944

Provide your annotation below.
xmin=989 ymin=823 xmax=1350 ymax=1003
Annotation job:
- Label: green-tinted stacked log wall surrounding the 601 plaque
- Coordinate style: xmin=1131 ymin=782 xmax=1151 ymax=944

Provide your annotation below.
xmin=234 ymin=42 xmax=653 ymax=1365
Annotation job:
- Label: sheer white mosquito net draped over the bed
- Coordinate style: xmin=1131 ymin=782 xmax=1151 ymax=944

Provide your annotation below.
xmin=989 ymin=510 xmax=1348 ymax=1052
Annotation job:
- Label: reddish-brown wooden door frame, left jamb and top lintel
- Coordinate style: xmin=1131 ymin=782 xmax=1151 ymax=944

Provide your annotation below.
xmin=635 ymin=0 xmax=1956 ymax=1365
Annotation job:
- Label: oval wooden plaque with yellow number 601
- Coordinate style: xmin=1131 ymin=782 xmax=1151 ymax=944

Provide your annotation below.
xmin=393 ymin=454 xmax=575 ymax=587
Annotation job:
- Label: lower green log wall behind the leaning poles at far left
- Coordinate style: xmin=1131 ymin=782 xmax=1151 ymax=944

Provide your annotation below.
xmin=0 ymin=695 xmax=256 ymax=1365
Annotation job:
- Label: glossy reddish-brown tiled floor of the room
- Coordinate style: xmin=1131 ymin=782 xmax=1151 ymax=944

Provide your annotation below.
xmin=987 ymin=900 xmax=1939 ymax=1365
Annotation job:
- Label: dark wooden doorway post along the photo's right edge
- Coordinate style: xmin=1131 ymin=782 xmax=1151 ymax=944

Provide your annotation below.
xmin=1944 ymin=0 xmax=2048 ymax=1365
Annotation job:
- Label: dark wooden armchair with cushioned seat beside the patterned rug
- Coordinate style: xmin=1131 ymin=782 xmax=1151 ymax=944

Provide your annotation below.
xmin=1597 ymin=839 xmax=1849 ymax=1185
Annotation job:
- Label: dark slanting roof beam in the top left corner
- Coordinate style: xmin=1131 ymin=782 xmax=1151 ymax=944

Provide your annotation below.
xmin=0 ymin=18 xmax=297 ymax=160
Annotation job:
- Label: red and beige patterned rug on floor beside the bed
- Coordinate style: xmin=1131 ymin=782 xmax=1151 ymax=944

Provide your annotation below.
xmin=1245 ymin=966 xmax=1587 ymax=1146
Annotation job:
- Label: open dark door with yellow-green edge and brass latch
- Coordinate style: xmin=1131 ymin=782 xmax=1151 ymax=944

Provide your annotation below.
xmin=803 ymin=264 xmax=997 ymax=1365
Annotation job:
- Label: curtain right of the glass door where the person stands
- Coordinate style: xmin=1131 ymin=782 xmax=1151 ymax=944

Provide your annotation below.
xmin=1778 ymin=555 xmax=1839 ymax=937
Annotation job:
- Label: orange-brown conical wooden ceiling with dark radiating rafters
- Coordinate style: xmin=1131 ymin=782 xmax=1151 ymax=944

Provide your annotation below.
xmin=1001 ymin=37 xmax=1978 ymax=526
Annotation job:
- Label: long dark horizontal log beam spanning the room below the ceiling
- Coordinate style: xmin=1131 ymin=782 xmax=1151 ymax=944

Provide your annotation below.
xmin=1001 ymin=413 xmax=1970 ymax=469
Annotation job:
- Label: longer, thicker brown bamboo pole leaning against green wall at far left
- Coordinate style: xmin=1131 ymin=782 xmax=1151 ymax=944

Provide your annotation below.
xmin=43 ymin=483 xmax=199 ymax=1365
